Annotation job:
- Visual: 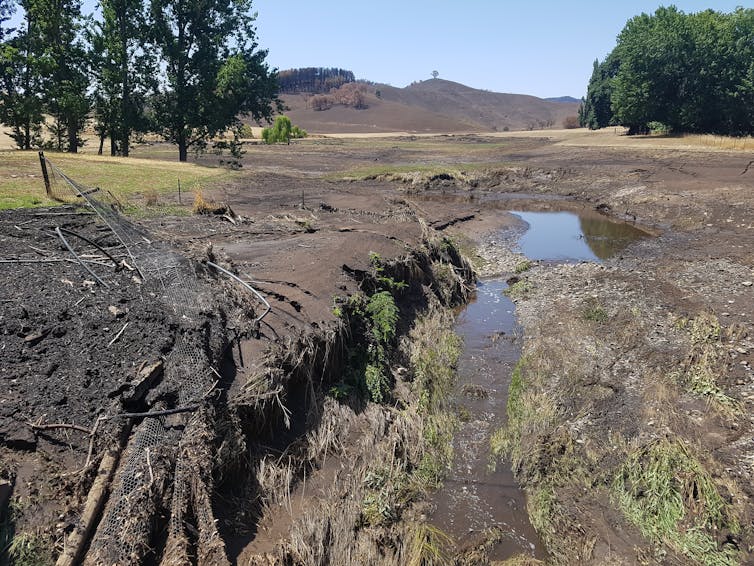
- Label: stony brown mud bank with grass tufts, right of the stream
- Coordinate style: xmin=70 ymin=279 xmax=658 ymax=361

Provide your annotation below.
xmin=480 ymin=206 xmax=754 ymax=564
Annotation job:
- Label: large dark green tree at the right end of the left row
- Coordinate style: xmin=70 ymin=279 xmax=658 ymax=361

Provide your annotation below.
xmin=151 ymin=0 xmax=282 ymax=161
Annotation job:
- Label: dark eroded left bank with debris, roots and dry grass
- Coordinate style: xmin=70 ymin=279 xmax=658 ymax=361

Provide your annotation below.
xmin=1 ymin=202 xmax=488 ymax=564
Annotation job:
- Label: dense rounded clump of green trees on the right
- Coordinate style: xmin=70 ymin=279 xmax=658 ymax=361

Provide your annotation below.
xmin=579 ymin=6 xmax=754 ymax=136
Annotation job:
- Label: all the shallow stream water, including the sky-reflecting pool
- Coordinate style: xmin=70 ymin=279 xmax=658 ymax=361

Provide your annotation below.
xmin=430 ymin=207 xmax=647 ymax=560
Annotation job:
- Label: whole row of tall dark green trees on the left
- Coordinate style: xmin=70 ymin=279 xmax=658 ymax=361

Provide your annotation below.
xmin=0 ymin=0 xmax=282 ymax=161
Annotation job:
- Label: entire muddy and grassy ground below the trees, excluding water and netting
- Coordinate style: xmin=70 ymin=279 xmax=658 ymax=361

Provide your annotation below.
xmin=0 ymin=129 xmax=754 ymax=564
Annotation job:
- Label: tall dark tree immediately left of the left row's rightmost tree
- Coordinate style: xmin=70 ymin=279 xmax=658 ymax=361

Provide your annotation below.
xmin=90 ymin=0 xmax=157 ymax=157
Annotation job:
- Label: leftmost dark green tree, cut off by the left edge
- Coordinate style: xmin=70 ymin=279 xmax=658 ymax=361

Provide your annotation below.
xmin=0 ymin=0 xmax=44 ymax=149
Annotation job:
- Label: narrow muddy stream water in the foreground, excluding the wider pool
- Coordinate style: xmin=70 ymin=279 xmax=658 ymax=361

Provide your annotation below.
xmin=430 ymin=280 xmax=543 ymax=560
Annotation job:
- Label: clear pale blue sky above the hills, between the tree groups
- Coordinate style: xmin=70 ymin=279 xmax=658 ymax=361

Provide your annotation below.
xmin=253 ymin=0 xmax=754 ymax=98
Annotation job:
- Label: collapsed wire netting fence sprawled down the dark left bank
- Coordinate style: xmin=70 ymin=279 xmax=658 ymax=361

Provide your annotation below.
xmin=44 ymin=158 xmax=250 ymax=564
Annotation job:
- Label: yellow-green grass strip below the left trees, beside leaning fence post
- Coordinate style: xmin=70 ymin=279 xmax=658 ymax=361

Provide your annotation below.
xmin=0 ymin=150 xmax=238 ymax=213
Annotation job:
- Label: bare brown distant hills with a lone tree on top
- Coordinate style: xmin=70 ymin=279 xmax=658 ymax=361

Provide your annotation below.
xmin=282 ymin=79 xmax=579 ymax=133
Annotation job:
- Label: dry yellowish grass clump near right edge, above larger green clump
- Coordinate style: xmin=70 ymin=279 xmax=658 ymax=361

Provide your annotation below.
xmin=671 ymin=313 xmax=741 ymax=417
